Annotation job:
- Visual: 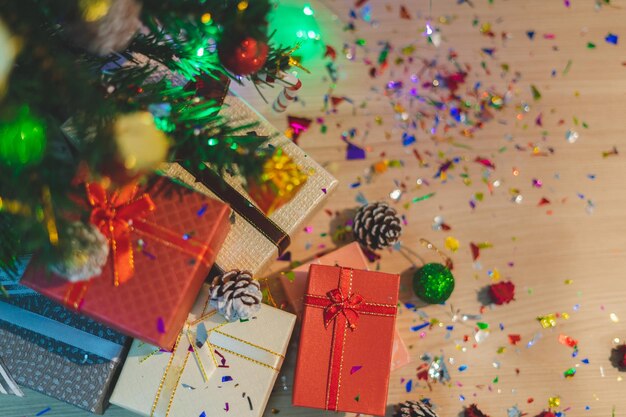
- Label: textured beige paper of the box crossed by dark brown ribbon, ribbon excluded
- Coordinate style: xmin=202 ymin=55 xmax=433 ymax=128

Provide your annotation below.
xmin=165 ymin=92 xmax=337 ymax=274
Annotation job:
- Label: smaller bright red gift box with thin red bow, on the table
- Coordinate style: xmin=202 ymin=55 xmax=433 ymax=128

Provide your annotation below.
xmin=293 ymin=265 xmax=400 ymax=416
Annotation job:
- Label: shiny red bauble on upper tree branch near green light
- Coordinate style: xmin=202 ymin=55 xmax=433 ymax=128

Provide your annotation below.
xmin=217 ymin=37 xmax=269 ymax=75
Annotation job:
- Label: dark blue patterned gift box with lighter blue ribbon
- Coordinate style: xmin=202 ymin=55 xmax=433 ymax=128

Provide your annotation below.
xmin=0 ymin=261 xmax=130 ymax=414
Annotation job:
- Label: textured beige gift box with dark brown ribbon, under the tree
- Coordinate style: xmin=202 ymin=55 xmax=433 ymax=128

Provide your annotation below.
xmin=164 ymin=93 xmax=337 ymax=275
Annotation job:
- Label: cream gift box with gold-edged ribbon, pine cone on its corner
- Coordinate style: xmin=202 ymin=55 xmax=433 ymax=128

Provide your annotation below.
xmin=111 ymin=285 xmax=295 ymax=417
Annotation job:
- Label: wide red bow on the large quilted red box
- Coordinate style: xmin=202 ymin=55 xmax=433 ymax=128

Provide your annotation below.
xmin=86 ymin=183 xmax=156 ymax=286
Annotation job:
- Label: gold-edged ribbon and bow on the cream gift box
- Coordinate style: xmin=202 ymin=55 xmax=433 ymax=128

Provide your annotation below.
xmin=142 ymin=298 xmax=285 ymax=417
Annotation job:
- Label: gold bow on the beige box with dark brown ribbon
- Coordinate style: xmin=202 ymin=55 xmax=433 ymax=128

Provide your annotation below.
xmin=248 ymin=148 xmax=308 ymax=215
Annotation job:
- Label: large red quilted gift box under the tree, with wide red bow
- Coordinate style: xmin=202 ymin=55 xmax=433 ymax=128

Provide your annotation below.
xmin=21 ymin=178 xmax=230 ymax=349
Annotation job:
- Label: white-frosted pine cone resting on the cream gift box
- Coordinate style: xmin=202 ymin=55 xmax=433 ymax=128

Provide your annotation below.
xmin=211 ymin=269 xmax=263 ymax=321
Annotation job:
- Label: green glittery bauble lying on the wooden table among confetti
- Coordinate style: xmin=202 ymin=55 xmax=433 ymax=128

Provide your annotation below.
xmin=413 ymin=263 xmax=454 ymax=304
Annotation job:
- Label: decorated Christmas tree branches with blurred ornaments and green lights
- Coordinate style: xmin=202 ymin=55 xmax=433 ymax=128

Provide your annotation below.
xmin=0 ymin=0 xmax=297 ymax=278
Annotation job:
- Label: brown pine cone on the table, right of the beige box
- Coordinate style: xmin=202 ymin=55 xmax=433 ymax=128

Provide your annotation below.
xmin=353 ymin=202 xmax=402 ymax=250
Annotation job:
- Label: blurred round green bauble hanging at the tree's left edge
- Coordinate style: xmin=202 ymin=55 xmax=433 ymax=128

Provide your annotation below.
xmin=0 ymin=106 xmax=47 ymax=168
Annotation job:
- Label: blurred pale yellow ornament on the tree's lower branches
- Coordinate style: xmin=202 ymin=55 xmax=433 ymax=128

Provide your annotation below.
xmin=113 ymin=112 xmax=170 ymax=173
